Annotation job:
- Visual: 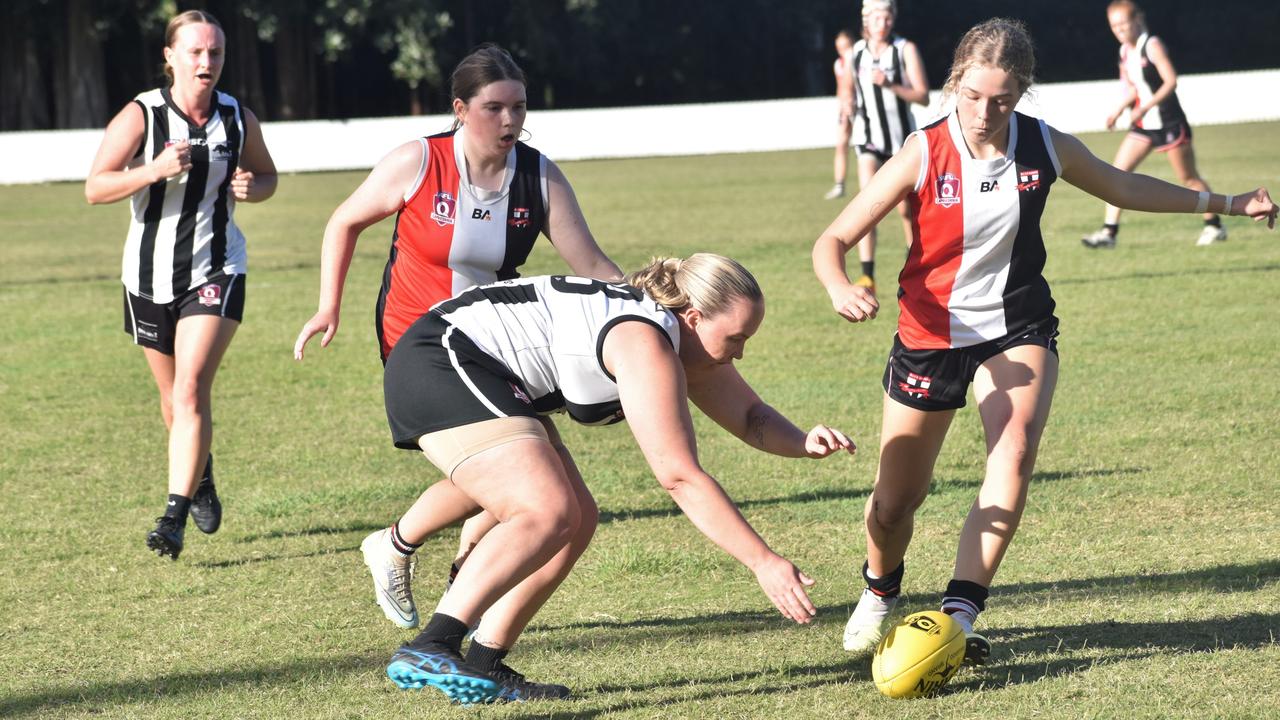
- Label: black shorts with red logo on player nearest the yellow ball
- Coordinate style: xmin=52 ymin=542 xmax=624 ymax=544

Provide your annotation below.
xmin=883 ymin=315 xmax=1057 ymax=410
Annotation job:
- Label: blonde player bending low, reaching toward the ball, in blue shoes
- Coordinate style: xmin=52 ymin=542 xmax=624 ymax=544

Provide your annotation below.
xmin=373 ymin=254 xmax=854 ymax=703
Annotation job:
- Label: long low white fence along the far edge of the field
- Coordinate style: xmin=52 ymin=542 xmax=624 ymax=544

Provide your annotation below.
xmin=0 ymin=69 xmax=1280 ymax=184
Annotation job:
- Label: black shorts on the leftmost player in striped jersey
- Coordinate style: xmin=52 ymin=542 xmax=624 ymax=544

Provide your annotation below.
xmin=124 ymin=274 xmax=246 ymax=355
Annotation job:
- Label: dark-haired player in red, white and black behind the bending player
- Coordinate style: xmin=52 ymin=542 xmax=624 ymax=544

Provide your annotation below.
xmin=293 ymin=45 xmax=622 ymax=628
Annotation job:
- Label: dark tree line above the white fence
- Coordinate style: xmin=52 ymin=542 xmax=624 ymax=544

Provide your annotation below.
xmin=0 ymin=0 xmax=1280 ymax=131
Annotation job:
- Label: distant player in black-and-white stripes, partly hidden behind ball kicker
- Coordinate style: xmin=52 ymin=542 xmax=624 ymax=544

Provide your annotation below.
xmin=841 ymin=0 xmax=929 ymax=293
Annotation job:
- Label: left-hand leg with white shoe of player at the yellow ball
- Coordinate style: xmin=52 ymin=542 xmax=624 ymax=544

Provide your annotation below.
xmin=844 ymin=395 xmax=955 ymax=652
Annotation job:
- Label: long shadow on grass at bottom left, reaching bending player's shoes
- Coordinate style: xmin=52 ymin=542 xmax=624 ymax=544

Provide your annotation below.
xmin=0 ymin=653 xmax=376 ymax=717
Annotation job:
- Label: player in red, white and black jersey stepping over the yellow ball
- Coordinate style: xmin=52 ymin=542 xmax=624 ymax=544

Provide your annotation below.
xmin=813 ymin=19 xmax=1276 ymax=662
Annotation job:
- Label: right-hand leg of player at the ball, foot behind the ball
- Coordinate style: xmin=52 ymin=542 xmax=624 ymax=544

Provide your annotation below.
xmin=942 ymin=345 xmax=1057 ymax=662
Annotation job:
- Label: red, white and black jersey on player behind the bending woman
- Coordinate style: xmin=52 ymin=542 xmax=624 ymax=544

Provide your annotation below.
xmin=376 ymin=129 xmax=547 ymax=360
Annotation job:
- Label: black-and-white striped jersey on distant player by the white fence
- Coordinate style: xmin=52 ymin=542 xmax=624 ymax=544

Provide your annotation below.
xmin=851 ymin=36 xmax=915 ymax=155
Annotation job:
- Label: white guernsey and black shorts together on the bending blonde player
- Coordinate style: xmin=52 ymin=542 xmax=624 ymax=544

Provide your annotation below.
xmin=384 ymin=275 xmax=680 ymax=448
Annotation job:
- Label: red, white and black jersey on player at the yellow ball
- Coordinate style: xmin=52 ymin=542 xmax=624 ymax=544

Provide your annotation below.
xmin=897 ymin=111 xmax=1061 ymax=350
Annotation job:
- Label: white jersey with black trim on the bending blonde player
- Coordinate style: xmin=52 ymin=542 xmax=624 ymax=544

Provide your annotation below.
xmin=431 ymin=275 xmax=680 ymax=424
